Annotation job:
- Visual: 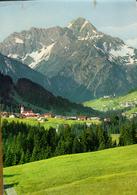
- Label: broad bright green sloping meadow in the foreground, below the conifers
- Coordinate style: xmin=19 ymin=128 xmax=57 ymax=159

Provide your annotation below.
xmin=4 ymin=145 xmax=137 ymax=195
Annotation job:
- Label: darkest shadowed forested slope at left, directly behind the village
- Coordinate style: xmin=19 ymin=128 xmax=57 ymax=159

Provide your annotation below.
xmin=0 ymin=73 xmax=97 ymax=115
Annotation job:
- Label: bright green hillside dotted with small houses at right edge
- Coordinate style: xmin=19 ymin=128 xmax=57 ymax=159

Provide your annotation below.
xmin=83 ymin=90 xmax=137 ymax=114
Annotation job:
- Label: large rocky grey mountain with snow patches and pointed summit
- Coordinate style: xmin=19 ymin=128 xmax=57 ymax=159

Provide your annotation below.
xmin=0 ymin=18 xmax=137 ymax=102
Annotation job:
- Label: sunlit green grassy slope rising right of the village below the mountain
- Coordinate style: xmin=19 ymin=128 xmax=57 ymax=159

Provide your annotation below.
xmin=84 ymin=91 xmax=137 ymax=111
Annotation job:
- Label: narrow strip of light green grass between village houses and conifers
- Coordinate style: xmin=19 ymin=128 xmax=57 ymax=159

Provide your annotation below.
xmin=3 ymin=118 xmax=101 ymax=129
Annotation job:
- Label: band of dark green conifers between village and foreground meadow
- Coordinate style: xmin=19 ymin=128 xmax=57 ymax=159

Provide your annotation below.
xmin=2 ymin=115 xmax=137 ymax=167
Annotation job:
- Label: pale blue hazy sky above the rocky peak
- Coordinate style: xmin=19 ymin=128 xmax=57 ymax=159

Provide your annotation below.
xmin=0 ymin=0 xmax=137 ymax=48
